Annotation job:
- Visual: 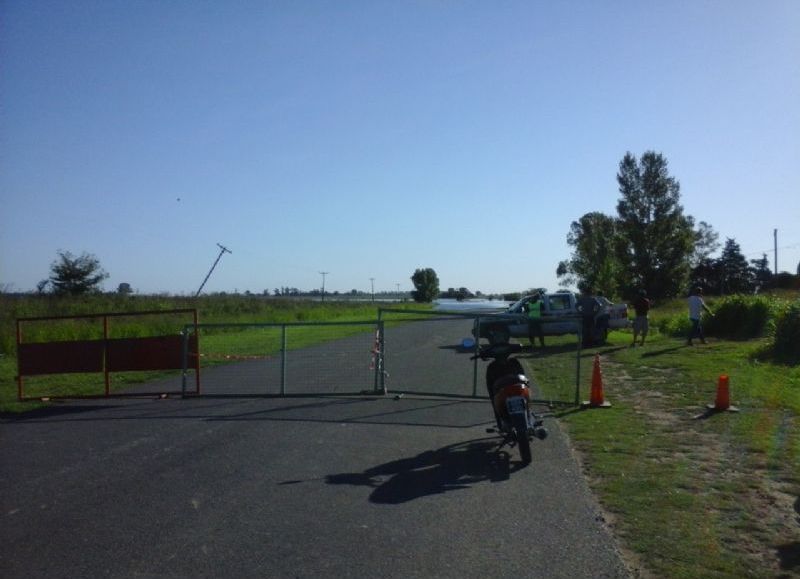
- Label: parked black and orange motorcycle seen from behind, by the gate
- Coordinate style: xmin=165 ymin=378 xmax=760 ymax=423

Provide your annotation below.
xmin=472 ymin=324 xmax=547 ymax=464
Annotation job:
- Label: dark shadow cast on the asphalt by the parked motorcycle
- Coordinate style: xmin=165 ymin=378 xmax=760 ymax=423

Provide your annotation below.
xmin=325 ymin=438 xmax=524 ymax=505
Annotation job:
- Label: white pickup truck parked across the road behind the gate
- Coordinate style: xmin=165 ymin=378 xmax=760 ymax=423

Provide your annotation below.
xmin=480 ymin=292 xmax=628 ymax=346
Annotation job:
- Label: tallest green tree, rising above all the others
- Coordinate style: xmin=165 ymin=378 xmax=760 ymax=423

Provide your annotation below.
xmin=616 ymin=151 xmax=697 ymax=298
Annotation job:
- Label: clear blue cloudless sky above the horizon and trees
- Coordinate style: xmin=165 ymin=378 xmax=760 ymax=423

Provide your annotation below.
xmin=0 ymin=0 xmax=800 ymax=294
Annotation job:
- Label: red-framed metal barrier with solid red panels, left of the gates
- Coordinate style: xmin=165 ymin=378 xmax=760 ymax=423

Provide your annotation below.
xmin=17 ymin=309 xmax=200 ymax=400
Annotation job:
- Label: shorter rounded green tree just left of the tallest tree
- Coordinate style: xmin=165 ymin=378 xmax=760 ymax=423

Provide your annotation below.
xmin=556 ymin=212 xmax=620 ymax=296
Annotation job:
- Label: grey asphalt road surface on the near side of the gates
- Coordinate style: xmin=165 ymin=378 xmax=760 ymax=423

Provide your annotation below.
xmin=0 ymin=318 xmax=627 ymax=578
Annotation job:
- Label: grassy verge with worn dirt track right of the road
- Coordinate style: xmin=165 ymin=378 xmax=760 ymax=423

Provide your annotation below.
xmin=527 ymin=332 xmax=800 ymax=577
